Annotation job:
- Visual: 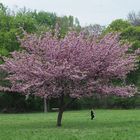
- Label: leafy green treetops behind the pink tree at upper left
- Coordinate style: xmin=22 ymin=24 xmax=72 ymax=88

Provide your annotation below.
xmin=0 ymin=4 xmax=80 ymax=56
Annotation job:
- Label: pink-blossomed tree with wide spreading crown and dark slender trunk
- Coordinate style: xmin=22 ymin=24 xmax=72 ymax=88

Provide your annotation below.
xmin=0 ymin=32 xmax=137 ymax=126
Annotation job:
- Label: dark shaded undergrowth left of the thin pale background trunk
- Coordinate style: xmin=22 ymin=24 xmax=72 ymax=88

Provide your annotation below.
xmin=0 ymin=93 xmax=43 ymax=113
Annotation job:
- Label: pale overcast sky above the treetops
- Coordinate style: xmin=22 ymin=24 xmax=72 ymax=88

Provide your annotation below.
xmin=0 ymin=0 xmax=140 ymax=26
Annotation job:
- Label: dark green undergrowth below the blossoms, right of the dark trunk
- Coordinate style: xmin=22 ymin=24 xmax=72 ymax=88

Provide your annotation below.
xmin=69 ymin=95 xmax=140 ymax=110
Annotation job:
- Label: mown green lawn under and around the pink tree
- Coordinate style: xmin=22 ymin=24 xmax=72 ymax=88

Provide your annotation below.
xmin=0 ymin=110 xmax=140 ymax=140
